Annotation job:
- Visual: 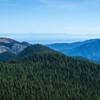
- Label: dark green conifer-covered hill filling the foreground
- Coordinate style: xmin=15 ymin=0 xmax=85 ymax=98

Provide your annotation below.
xmin=0 ymin=39 xmax=100 ymax=100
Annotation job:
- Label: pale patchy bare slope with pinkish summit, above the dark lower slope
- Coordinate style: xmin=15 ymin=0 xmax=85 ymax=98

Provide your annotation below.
xmin=0 ymin=38 xmax=30 ymax=54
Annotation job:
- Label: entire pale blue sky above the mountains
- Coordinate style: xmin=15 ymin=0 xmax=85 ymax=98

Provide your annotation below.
xmin=0 ymin=0 xmax=100 ymax=43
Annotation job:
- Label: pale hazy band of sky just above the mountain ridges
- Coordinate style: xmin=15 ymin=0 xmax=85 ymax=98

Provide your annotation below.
xmin=0 ymin=33 xmax=100 ymax=44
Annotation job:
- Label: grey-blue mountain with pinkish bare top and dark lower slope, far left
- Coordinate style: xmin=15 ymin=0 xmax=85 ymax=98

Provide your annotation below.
xmin=0 ymin=38 xmax=30 ymax=61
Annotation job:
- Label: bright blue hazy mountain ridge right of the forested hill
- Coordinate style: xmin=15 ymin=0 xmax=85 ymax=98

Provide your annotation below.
xmin=48 ymin=39 xmax=100 ymax=63
